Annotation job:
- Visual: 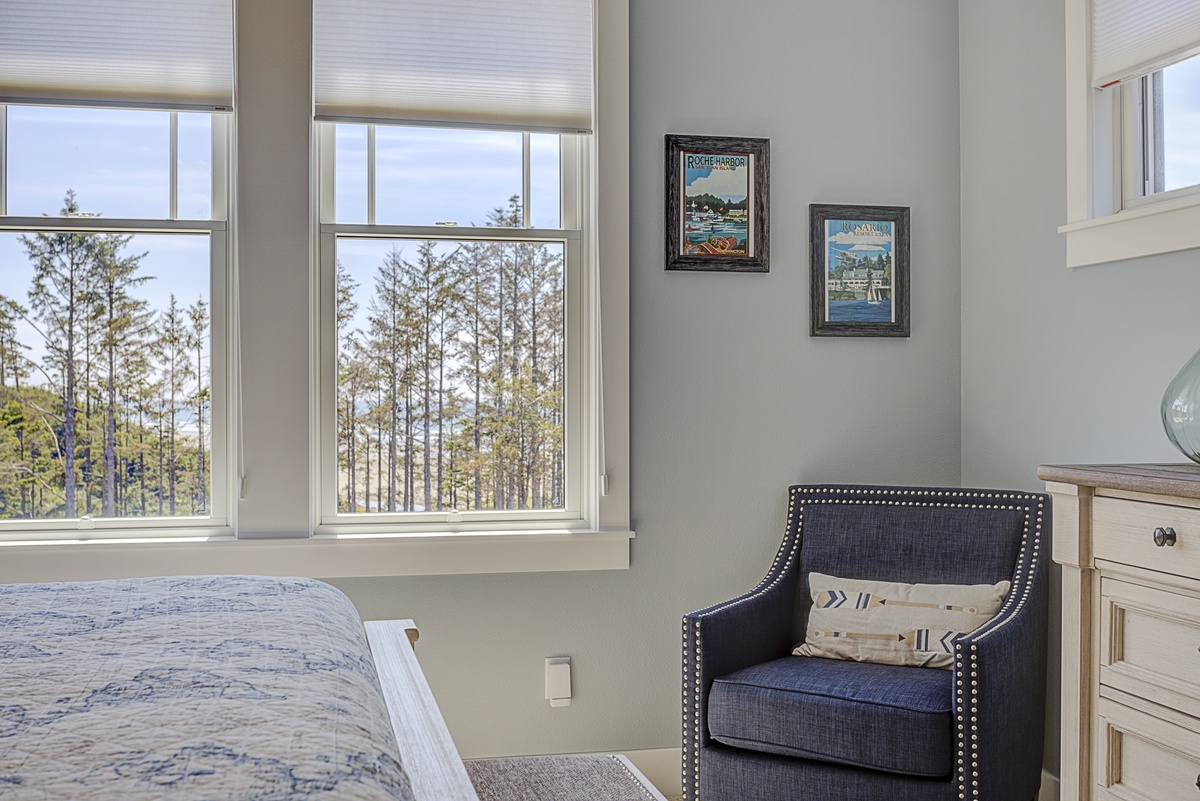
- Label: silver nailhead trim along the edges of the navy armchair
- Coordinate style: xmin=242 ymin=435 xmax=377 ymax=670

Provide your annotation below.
xmin=683 ymin=487 xmax=1045 ymax=801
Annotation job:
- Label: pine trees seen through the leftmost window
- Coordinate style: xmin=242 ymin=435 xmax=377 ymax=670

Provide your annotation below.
xmin=0 ymin=192 xmax=211 ymax=519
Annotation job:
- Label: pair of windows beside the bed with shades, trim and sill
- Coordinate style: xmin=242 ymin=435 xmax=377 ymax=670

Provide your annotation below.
xmin=0 ymin=0 xmax=632 ymax=580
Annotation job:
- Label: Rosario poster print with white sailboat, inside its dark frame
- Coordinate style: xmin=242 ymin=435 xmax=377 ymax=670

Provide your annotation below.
xmin=826 ymin=219 xmax=895 ymax=323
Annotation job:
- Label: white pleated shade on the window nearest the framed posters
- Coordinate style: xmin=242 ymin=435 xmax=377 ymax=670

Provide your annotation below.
xmin=313 ymin=0 xmax=593 ymax=132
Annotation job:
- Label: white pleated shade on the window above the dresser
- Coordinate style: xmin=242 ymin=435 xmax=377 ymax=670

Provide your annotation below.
xmin=1092 ymin=0 xmax=1200 ymax=88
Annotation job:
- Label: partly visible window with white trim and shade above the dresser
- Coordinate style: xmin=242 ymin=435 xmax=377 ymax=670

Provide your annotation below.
xmin=1061 ymin=0 xmax=1200 ymax=266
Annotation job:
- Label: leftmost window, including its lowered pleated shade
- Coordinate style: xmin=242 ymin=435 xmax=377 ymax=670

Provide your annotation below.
xmin=0 ymin=0 xmax=233 ymax=540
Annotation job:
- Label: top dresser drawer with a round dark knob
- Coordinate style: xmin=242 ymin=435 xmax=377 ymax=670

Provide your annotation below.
xmin=1092 ymin=496 xmax=1200 ymax=577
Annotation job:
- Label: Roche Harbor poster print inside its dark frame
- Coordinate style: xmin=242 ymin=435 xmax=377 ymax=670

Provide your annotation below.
xmin=679 ymin=151 xmax=755 ymax=257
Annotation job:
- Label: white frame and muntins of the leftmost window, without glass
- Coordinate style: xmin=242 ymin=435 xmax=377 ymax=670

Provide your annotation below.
xmin=0 ymin=104 xmax=233 ymax=543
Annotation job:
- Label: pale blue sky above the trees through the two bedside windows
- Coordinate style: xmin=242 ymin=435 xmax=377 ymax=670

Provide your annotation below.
xmin=0 ymin=106 xmax=559 ymax=376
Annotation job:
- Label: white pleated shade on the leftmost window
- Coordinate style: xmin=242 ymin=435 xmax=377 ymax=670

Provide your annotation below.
xmin=0 ymin=0 xmax=233 ymax=110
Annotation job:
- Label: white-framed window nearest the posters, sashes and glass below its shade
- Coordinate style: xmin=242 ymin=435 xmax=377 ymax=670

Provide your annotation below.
xmin=322 ymin=124 xmax=587 ymax=531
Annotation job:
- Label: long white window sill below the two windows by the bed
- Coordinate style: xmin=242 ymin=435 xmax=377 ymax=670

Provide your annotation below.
xmin=0 ymin=531 xmax=634 ymax=583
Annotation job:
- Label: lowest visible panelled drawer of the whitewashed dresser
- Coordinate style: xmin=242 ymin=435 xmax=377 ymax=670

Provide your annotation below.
xmin=1096 ymin=698 xmax=1200 ymax=801
